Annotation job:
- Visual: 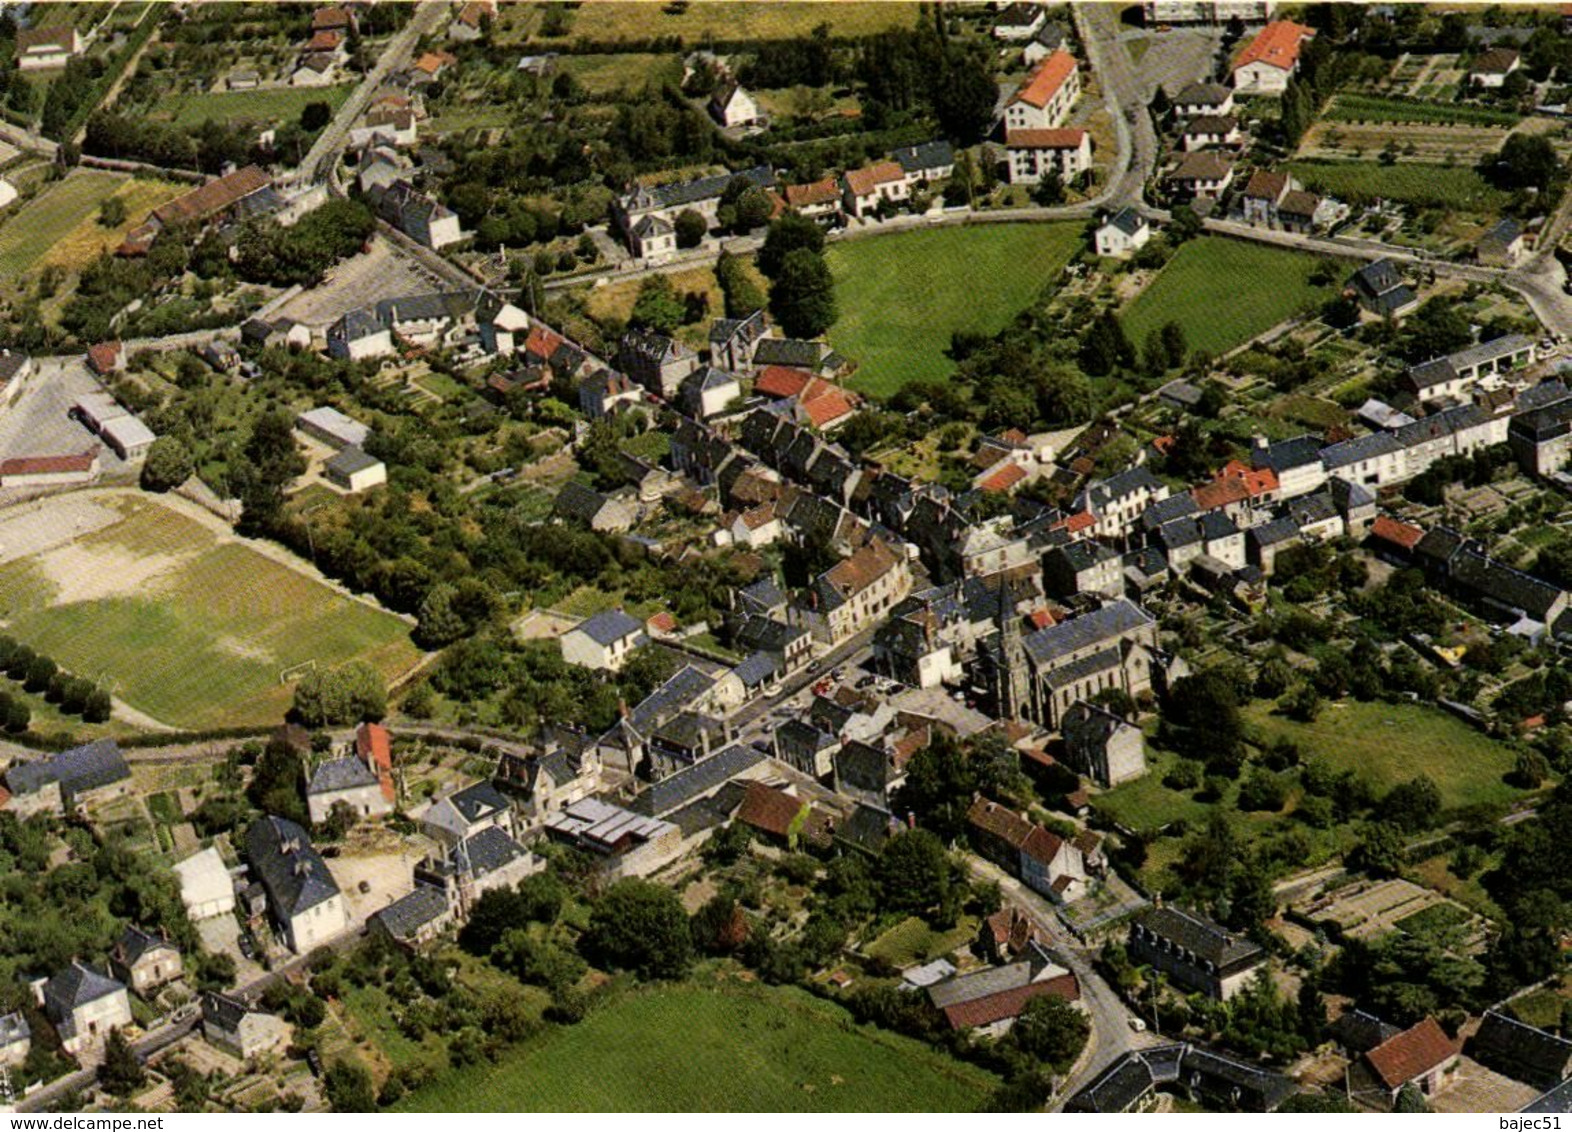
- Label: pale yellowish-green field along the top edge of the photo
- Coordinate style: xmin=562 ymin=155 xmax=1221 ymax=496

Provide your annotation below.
xmin=550 ymin=0 xmax=918 ymax=46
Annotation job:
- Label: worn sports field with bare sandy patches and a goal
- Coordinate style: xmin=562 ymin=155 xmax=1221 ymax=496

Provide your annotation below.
xmin=0 ymin=495 xmax=418 ymax=728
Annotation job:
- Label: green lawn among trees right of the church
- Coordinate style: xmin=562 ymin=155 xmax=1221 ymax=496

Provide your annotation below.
xmin=1245 ymin=700 xmax=1522 ymax=807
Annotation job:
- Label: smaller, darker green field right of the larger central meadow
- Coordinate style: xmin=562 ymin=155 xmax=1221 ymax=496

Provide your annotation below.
xmin=1124 ymin=236 xmax=1338 ymax=354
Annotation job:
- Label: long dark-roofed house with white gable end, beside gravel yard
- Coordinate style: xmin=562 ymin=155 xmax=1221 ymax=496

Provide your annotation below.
xmin=245 ymin=816 xmax=351 ymax=954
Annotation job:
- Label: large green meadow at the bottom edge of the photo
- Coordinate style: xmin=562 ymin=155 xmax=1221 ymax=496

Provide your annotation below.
xmin=396 ymin=984 xmax=997 ymax=1112
